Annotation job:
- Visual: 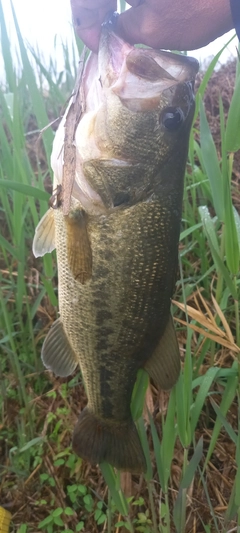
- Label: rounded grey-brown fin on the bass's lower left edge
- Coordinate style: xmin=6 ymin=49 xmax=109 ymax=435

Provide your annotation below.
xmin=41 ymin=318 xmax=78 ymax=377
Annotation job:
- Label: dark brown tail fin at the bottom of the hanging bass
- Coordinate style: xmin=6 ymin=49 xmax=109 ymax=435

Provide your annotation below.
xmin=73 ymin=407 xmax=146 ymax=473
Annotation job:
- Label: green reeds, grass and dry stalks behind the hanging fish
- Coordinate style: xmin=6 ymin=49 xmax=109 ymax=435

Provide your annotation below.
xmin=0 ymin=2 xmax=240 ymax=533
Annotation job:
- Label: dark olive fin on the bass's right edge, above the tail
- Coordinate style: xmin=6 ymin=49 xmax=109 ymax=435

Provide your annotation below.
xmin=144 ymin=315 xmax=180 ymax=390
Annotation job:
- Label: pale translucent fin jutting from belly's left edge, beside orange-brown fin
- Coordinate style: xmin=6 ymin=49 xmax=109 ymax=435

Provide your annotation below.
xmin=32 ymin=208 xmax=55 ymax=257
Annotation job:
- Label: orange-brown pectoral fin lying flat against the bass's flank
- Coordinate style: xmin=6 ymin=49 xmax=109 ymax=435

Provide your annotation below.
xmin=65 ymin=209 xmax=92 ymax=284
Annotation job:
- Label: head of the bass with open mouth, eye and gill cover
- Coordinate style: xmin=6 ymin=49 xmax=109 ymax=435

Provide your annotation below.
xmin=76 ymin=25 xmax=198 ymax=207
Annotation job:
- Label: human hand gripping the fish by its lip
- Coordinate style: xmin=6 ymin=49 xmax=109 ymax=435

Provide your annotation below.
xmin=71 ymin=0 xmax=233 ymax=52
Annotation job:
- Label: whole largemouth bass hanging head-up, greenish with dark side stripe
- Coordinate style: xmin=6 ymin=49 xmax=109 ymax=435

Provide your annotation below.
xmin=33 ymin=25 xmax=198 ymax=472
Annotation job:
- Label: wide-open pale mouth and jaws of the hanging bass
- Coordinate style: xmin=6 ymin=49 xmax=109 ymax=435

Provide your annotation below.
xmin=83 ymin=25 xmax=199 ymax=111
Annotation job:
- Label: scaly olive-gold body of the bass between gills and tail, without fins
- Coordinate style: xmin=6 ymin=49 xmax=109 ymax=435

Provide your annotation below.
xmin=54 ymin=197 xmax=178 ymax=430
